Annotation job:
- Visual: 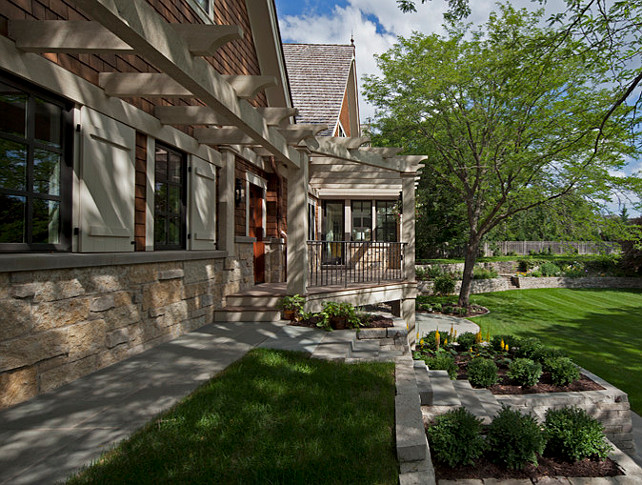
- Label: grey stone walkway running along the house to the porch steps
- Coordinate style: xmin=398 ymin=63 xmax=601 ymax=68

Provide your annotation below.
xmin=0 ymin=322 xmax=398 ymax=485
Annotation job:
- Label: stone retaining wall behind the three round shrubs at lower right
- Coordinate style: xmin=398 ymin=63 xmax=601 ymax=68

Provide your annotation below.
xmin=495 ymin=369 xmax=635 ymax=455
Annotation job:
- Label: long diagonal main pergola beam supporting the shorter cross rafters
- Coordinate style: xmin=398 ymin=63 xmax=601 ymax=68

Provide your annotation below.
xmin=75 ymin=0 xmax=301 ymax=167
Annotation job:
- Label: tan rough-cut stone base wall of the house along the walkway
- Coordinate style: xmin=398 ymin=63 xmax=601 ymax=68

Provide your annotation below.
xmin=0 ymin=244 xmax=253 ymax=408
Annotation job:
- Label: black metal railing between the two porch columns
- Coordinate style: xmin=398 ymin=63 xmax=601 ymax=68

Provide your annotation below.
xmin=308 ymin=241 xmax=406 ymax=286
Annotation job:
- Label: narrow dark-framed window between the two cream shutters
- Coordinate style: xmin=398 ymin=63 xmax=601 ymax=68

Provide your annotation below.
xmin=154 ymin=142 xmax=187 ymax=249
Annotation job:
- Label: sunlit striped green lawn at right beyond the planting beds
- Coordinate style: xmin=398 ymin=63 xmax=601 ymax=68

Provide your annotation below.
xmin=471 ymin=289 xmax=642 ymax=413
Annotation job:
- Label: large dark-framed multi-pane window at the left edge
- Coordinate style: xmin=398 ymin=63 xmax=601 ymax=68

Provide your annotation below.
xmin=0 ymin=76 xmax=71 ymax=251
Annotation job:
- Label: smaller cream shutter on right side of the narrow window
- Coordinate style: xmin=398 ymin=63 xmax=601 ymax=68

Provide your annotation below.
xmin=189 ymin=156 xmax=216 ymax=250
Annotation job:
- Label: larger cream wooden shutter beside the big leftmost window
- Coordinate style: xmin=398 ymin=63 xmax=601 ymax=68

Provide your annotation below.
xmin=80 ymin=107 xmax=136 ymax=252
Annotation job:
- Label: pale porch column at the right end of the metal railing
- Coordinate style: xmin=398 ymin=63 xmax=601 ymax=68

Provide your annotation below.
xmin=401 ymin=172 xmax=417 ymax=336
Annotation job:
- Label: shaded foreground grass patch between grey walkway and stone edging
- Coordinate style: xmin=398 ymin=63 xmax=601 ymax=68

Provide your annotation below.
xmin=68 ymin=349 xmax=398 ymax=484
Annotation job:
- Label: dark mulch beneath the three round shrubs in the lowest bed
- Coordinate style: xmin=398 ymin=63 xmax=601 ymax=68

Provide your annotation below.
xmin=433 ymin=456 xmax=623 ymax=480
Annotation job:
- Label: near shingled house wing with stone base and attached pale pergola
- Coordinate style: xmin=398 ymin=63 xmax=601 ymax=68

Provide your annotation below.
xmin=0 ymin=0 xmax=418 ymax=407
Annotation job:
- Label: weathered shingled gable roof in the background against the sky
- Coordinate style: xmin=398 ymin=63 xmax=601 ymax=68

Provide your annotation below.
xmin=283 ymin=44 xmax=354 ymax=135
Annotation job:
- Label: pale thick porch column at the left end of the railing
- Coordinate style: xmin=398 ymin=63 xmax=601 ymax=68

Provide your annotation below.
xmin=287 ymin=152 xmax=309 ymax=295
